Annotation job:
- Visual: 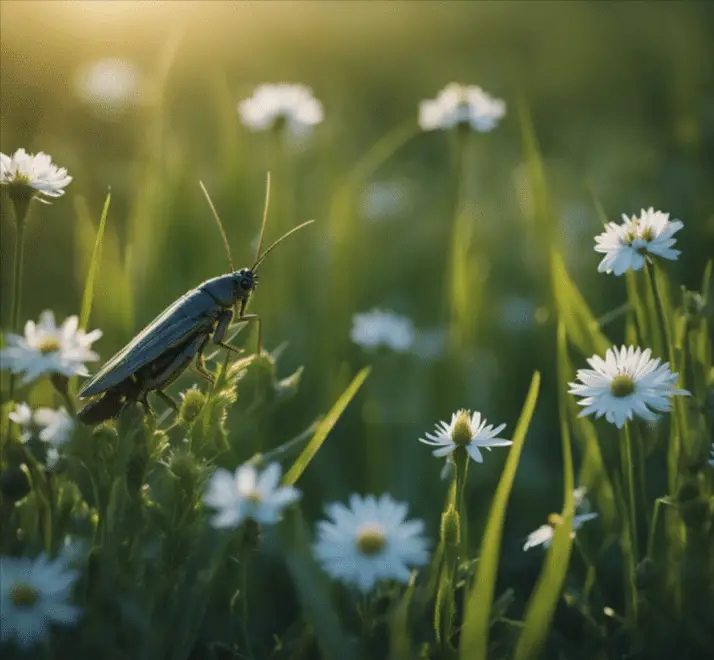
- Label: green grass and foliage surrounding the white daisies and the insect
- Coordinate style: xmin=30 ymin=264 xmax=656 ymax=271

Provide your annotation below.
xmin=0 ymin=3 xmax=714 ymax=660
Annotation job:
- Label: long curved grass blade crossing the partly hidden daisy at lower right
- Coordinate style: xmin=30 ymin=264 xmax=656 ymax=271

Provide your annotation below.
xmin=513 ymin=321 xmax=575 ymax=660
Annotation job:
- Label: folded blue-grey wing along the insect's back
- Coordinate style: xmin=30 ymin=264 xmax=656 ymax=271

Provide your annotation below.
xmin=79 ymin=289 xmax=221 ymax=399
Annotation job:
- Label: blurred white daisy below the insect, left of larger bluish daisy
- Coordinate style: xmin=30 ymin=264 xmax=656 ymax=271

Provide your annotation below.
xmin=203 ymin=463 xmax=301 ymax=528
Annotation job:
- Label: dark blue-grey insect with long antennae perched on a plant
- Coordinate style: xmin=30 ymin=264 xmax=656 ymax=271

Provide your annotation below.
xmin=78 ymin=173 xmax=314 ymax=425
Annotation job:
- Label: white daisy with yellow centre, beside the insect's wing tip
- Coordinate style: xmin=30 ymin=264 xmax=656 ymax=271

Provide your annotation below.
xmin=0 ymin=311 xmax=102 ymax=385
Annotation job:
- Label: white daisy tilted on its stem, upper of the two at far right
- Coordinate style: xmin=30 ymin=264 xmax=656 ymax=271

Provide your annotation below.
xmin=595 ymin=208 xmax=684 ymax=275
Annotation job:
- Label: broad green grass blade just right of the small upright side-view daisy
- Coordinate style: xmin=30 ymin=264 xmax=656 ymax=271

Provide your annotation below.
xmin=459 ymin=371 xmax=540 ymax=660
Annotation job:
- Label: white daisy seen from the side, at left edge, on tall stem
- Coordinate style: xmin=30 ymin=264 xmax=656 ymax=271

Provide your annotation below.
xmin=0 ymin=149 xmax=72 ymax=197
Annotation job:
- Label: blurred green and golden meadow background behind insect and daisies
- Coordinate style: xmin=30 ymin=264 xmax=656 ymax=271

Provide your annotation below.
xmin=0 ymin=0 xmax=714 ymax=608
